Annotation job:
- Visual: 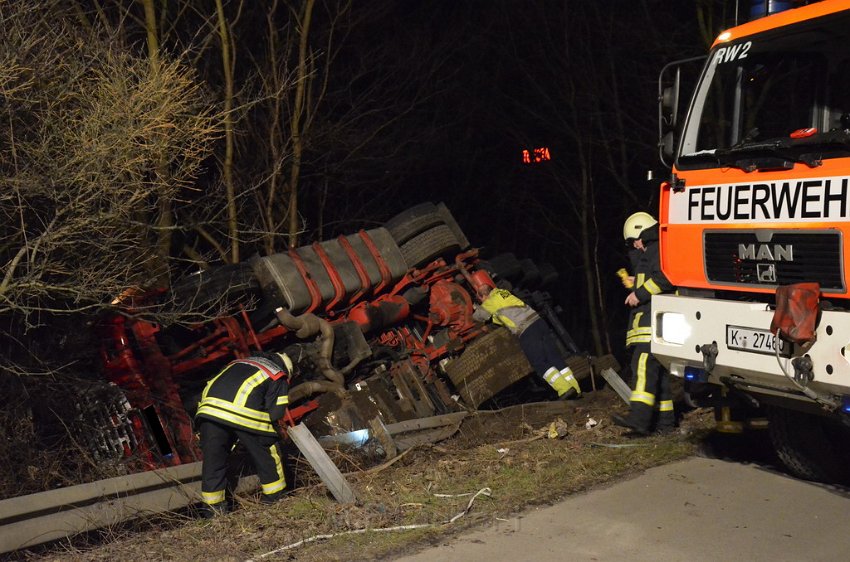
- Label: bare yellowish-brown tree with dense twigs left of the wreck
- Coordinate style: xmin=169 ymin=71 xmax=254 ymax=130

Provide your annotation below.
xmin=0 ymin=2 xmax=218 ymax=342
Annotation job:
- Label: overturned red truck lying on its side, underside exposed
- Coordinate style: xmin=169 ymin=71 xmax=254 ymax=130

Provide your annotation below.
xmin=93 ymin=203 xmax=616 ymax=469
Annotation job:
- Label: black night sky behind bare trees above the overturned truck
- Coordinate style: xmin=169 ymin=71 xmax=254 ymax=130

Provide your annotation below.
xmin=288 ymin=0 xmax=712 ymax=347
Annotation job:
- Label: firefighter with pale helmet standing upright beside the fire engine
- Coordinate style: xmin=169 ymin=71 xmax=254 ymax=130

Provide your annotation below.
xmin=612 ymin=212 xmax=676 ymax=435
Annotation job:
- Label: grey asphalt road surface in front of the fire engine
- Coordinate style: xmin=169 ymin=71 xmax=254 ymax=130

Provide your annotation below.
xmin=398 ymin=458 xmax=850 ymax=562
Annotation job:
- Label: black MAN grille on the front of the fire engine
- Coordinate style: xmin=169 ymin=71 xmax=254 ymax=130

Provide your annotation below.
xmin=703 ymin=230 xmax=844 ymax=292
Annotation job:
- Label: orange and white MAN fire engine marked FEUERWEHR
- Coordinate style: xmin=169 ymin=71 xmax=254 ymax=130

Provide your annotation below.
xmin=652 ymin=0 xmax=850 ymax=481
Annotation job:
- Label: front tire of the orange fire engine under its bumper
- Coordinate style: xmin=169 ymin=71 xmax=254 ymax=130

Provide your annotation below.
xmin=768 ymin=408 xmax=850 ymax=483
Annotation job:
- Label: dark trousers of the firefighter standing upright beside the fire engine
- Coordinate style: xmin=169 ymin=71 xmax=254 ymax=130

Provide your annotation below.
xmin=629 ymin=343 xmax=676 ymax=432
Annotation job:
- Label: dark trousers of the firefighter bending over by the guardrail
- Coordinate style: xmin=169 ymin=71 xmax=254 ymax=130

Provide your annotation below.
xmin=200 ymin=419 xmax=286 ymax=508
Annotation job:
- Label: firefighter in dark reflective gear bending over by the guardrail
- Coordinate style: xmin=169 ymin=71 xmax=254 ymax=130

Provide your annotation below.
xmin=195 ymin=352 xmax=292 ymax=516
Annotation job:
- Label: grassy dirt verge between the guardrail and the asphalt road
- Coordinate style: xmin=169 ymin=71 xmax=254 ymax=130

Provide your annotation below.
xmin=13 ymin=389 xmax=711 ymax=561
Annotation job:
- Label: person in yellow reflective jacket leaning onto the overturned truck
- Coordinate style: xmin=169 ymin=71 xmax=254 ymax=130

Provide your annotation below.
xmin=472 ymin=285 xmax=581 ymax=399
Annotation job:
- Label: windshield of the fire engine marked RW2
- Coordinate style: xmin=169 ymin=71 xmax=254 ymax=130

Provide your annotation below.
xmin=677 ymin=12 xmax=850 ymax=168
